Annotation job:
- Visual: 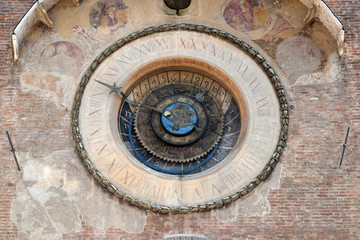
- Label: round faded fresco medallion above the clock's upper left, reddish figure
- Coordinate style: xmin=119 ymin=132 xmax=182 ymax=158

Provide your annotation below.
xmin=89 ymin=0 xmax=129 ymax=34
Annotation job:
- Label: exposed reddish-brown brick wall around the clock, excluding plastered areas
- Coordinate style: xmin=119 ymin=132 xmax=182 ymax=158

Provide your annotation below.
xmin=0 ymin=0 xmax=360 ymax=240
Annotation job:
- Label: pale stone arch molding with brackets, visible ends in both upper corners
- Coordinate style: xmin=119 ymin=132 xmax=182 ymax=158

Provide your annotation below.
xmin=12 ymin=0 xmax=345 ymax=61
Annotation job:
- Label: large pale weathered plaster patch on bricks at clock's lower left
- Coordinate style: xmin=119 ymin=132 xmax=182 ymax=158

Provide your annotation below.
xmin=11 ymin=149 xmax=146 ymax=239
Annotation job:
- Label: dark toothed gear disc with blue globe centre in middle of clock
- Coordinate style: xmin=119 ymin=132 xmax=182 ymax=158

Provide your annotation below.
xmin=134 ymin=84 xmax=224 ymax=162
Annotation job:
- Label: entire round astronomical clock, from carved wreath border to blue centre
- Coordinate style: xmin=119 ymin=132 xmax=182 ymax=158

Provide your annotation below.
xmin=73 ymin=24 xmax=288 ymax=213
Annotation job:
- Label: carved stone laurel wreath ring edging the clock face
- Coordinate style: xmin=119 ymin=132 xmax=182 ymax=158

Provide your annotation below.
xmin=72 ymin=23 xmax=289 ymax=214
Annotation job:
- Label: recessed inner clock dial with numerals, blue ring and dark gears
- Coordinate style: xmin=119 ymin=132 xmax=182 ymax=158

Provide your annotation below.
xmin=118 ymin=70 xmax=235 ymax=172
